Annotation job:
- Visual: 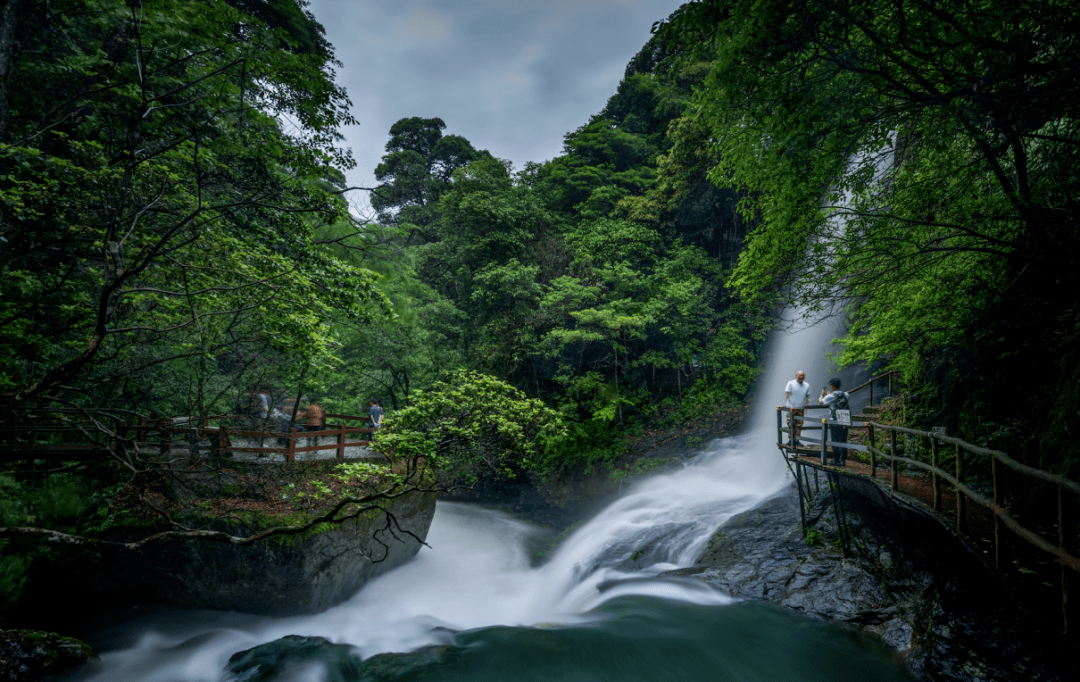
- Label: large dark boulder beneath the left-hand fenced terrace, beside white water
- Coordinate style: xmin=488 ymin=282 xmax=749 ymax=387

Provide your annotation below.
xmin=22 ymin=493 xmax=435 ymax=616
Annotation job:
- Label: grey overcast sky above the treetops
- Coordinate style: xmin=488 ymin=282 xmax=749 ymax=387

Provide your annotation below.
xmin=310 ymin=0 xmax=683 ymax=211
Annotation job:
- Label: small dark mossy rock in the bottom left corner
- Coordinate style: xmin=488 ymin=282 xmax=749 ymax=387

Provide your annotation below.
xmin=0 ymin=630 xmax=97 ymax=682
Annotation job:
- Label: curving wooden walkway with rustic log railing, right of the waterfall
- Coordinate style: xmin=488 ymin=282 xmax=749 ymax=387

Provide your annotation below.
xmin=777 ymin=395 xmax=1080 ymax=641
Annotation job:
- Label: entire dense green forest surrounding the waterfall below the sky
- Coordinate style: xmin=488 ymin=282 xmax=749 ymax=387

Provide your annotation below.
xmin=0 ymin=0 xmax=1080 ymax=631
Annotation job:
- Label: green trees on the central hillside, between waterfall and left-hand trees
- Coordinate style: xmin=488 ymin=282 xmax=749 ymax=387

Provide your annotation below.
xmin=345 ymin=32 xmax=771 ymax=471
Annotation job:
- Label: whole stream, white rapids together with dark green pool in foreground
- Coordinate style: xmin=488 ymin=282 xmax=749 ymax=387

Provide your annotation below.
xmin=71 ymin=311 xmax=903 ymax=682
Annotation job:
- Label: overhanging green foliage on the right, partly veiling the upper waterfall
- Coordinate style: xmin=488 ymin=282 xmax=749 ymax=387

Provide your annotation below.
xmin=659 ymin=0 xmax=1080 ymax=472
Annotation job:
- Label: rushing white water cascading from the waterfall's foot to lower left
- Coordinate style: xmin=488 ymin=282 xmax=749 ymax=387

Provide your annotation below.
xmin=82 ymin=311 xmax=851 ymax=682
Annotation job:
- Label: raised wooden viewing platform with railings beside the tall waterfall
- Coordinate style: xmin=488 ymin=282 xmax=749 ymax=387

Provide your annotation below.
xmin=777 ymin=375 xmax=1080 ymax=638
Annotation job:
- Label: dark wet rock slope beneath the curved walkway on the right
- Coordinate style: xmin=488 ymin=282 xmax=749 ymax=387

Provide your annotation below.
xmin=665 ymin=477 xmax=1078 ymax=682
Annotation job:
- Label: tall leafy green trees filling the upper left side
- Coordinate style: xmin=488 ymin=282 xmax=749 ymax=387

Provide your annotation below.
xmin=0 ymin=0 xmax=389 ymax=414
